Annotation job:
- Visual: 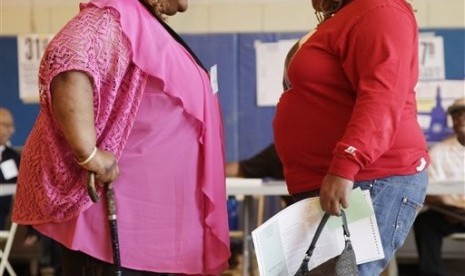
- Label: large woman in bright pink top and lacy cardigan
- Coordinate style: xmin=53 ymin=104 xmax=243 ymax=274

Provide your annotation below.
xmin=13 ymin=0 xmax=229 ymax=275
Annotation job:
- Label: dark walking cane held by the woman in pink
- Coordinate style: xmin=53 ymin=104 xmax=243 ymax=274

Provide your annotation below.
xmin=87 ymin=172 xmax=122 ymax=276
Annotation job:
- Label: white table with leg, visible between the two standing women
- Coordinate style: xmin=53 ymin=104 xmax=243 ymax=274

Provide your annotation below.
xmin=226 ymin=177 xmax=289 ymax=275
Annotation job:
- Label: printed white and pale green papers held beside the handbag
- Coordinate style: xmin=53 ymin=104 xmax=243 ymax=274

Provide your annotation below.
xmin=252 ymin=188 xmax=384 ymax=276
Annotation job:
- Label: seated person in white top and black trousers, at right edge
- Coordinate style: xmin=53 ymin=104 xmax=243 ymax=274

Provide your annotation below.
xmin=413 ymin=98 xmax=465 ymax=276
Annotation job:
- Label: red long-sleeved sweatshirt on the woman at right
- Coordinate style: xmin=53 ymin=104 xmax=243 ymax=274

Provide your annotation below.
xmin=273 ymin=0 xmax=429 ymax=194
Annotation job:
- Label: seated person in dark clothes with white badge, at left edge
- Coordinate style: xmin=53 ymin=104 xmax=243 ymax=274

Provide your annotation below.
xmin=0 ymin=107 xmax=20 ymax=229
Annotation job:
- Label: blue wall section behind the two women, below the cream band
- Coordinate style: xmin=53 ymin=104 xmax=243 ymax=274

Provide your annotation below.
xmin=0 ymin=29 xmax=465 ymax=161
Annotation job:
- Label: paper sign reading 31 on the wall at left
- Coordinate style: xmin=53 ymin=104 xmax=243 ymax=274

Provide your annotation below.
xmin=17 ymin=34 xmax=53 ymax=103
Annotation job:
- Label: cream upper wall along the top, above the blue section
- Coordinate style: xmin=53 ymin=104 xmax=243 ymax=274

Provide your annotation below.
xmin=0 ymin=0 xmax=465 ymax=35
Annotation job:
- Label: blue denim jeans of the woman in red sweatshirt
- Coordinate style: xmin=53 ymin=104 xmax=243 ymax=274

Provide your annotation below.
xmin=354 ymin=170 xmax=428 ymax=276
